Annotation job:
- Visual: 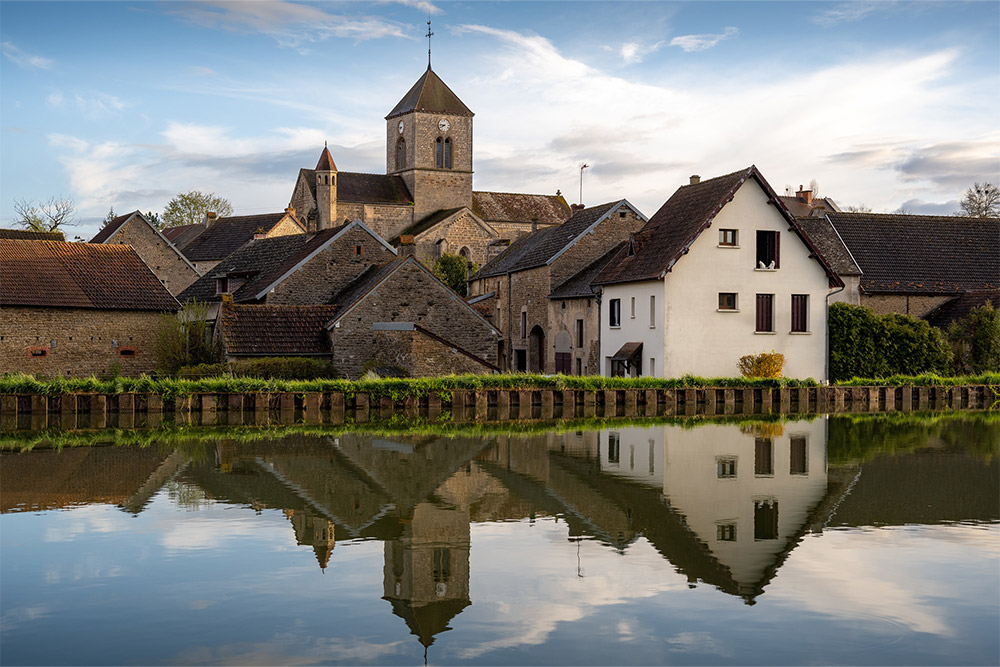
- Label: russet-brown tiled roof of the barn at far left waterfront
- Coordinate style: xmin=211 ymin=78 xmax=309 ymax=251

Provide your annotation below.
xmin=0 ymin=239 xmax=179 ymax=311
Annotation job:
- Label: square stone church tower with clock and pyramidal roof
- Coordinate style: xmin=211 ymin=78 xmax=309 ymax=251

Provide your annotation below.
xmin=384 ymin=65 xmax=474 ymax=222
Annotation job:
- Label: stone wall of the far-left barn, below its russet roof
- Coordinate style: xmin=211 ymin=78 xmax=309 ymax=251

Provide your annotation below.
xmin=0 ymin=306 xmax=160 ymax=377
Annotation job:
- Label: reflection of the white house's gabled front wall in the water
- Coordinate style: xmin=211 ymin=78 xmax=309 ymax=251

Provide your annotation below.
xmin=662 ymin=418 xmax=827 ymax=594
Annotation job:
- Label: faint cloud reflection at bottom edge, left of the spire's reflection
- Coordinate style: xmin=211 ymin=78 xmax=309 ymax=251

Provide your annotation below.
xmin=175 ymin=633 xmax=408 ymax=666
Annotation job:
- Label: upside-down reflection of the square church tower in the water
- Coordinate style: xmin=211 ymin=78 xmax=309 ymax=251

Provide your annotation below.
xmin=383 ymin=503 xmax=471 ymax=648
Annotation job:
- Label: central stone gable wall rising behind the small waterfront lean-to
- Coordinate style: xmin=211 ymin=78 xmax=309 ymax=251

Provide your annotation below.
xmin=331 ymin=262 xmax=498 ymax=377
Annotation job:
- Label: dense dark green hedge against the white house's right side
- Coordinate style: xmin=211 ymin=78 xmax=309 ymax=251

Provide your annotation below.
xmin=829 ymin=303 xmax=951 ymax=382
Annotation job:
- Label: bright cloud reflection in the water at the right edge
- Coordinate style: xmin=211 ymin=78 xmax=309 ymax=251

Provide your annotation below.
xmin=767 ymin=525 xmax=1000 ymax=637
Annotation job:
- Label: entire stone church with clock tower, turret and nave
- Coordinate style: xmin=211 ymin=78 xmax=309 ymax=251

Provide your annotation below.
xmin=289 ymin=65 xmax=571 ymax=265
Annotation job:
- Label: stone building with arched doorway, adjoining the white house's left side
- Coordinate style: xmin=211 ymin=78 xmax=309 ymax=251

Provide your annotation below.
xmin=469 ymin=199 xmax=646 ymax=375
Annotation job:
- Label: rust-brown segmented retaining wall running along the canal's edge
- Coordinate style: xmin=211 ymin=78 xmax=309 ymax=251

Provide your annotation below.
xmin=0 ymin=385 xmax=1000 ymax=430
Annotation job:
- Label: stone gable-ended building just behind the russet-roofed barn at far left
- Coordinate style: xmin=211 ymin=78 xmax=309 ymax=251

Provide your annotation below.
xmin=90 ymin=211 xmax=201 ymax=295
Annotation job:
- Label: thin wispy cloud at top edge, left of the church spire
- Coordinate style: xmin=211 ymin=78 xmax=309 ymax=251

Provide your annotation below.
xmin=168 ymin=0 xmax=408 ymax=54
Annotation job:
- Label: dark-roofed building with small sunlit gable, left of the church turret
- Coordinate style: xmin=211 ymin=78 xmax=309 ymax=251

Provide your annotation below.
xmin=163 ymin=208 xmax=305 ymax=275
